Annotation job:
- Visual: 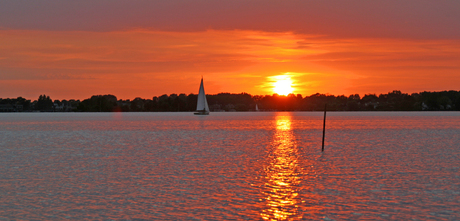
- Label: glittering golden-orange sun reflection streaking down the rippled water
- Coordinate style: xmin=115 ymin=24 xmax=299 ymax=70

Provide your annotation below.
xmin=260 ymin=116 xmax=303 ymax=220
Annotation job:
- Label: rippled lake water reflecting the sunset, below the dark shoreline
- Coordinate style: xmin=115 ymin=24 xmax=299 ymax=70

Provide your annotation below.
xmin=0 ymin=112 xmax=460 ymax=220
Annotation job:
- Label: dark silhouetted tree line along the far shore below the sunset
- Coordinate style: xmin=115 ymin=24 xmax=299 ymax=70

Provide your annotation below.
xmin=0 ymin=90 xmax=460 ymax=112
